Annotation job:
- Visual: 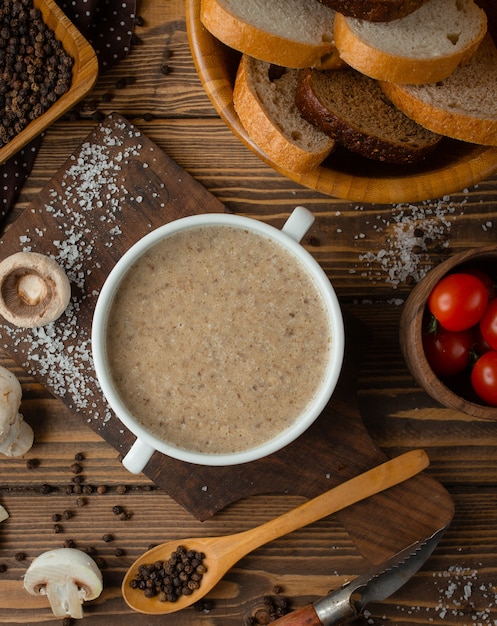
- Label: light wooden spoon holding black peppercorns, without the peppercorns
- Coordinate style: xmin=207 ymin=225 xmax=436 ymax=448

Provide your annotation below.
xmin=122 ymin=450 xmax=429 ymax=615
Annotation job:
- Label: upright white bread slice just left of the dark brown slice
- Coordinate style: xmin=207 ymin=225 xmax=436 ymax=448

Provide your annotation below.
xmin=233 ymin=54 xmax=335 ymax=172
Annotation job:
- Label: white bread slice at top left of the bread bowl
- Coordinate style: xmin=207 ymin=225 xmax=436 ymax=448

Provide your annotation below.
xmin=200 ymin=0 xmax=341 ymax=68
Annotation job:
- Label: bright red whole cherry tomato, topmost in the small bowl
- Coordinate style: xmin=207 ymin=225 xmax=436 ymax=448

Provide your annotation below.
xmin=428 ymin=273 xmax=488 ymax=331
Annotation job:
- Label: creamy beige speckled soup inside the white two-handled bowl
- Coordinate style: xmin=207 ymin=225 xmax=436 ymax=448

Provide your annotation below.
xmin=106 ymin=225 xmax=331 ymax=454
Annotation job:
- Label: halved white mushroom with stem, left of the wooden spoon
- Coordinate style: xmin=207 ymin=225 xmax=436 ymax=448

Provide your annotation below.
xmin=24 ymin=548 xmax=103 ymax=619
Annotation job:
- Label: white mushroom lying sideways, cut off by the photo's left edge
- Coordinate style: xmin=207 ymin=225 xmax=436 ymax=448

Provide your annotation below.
xmin=0 ymin=366 xmax=34 ymax=456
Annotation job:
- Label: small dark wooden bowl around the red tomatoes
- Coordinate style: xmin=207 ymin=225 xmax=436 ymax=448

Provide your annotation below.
xmin=400 ymin=246 xmax=497 ymax=420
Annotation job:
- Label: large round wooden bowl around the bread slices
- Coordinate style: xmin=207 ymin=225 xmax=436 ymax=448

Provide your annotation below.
xmin=186 ymin=0 xmax=497 ymax=203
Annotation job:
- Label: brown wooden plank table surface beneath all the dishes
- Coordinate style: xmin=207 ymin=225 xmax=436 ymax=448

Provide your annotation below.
xmin=0 ymin=0 xmax=497 ymax=626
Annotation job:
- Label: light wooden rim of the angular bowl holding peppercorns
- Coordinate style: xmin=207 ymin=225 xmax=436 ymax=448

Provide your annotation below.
xmin=0 ymin=0 xmax=98 ymax=164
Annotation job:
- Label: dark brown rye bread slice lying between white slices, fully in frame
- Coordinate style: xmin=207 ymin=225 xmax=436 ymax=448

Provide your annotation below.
xmin=295 ymin=69 xmax=441 ymax=164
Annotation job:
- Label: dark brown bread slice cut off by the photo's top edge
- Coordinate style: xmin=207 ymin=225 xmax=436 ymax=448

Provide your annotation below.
xmin=319 ymin=0 xmax=427 ymax=22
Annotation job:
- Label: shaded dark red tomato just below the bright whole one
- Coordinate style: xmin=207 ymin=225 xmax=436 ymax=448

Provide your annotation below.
xmin=423 ymin=326 xmax=474 ymax=378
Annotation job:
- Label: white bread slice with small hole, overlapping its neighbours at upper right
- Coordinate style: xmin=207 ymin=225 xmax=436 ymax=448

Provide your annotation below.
xmin=335 ymin=0 xmax=487 ymax=85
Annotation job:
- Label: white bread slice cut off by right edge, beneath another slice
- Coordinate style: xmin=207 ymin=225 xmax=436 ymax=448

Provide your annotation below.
xmin=381 ymin=35 xmax=497 ymax=146
